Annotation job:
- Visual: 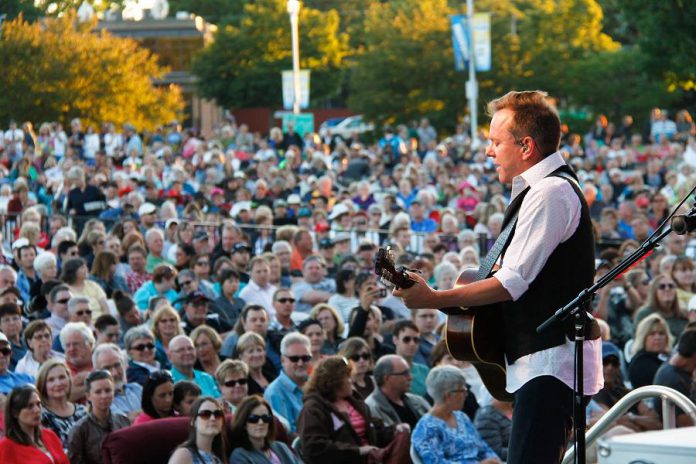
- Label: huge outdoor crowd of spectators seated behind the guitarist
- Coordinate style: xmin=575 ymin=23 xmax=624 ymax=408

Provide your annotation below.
xmin=0 ymin=105 xmax=696 ymax=463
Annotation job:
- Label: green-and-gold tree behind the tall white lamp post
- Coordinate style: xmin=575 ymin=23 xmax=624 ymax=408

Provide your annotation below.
xmin=193 ymin=0 xmax=347 ymax=108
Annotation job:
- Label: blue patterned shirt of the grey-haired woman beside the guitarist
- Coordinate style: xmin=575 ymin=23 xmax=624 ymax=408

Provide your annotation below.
xmin=411 ymin=411 xmax=498 ymax=464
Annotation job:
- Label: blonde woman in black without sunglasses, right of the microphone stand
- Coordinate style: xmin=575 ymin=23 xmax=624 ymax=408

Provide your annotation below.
xmin=628 ymin=314 xmax=674 ymax=388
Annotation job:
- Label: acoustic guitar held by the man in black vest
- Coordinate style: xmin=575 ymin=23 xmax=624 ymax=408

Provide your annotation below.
xmin=375 ymin=248 xmax=513 ymax=401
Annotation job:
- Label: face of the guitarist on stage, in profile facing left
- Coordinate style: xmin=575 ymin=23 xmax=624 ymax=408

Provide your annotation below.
xmin=486 ymin=109 xmax=525 ymax=184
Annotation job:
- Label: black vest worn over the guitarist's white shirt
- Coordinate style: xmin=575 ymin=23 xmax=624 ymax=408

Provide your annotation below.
xmin=502 ymin=166 xmax=597 ymax=364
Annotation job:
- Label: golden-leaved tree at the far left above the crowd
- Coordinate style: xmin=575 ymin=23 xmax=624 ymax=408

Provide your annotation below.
xmin=0 ymin=14 xmax=182 ymax=129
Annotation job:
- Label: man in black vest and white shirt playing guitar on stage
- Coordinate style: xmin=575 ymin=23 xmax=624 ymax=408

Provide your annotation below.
xmin=394 ymin=91 xmax=603 ymax=464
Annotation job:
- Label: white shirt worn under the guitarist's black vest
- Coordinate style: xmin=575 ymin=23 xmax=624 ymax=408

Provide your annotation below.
xmin=494 ymin=152 xmax=604 ymax=395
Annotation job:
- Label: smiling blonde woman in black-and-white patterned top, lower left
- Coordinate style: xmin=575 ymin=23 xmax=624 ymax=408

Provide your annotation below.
xmin=36 ymin=359 xmax=87 ymax=450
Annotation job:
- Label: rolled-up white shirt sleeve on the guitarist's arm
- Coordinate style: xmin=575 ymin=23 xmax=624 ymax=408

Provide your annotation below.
xmin=494 ymin=177 xmax=581 ymax=301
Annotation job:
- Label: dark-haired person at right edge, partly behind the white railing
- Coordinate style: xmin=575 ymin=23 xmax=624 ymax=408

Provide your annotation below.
xmin=654 ymin=329 xmax=696 ymax=427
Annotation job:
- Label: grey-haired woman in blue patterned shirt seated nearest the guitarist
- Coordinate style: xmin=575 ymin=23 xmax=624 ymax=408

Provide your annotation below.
xmin=411 ymin=366 xmax=500 ymax=464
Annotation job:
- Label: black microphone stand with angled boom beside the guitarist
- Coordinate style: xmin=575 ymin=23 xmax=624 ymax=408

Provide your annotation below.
xmin=536 ymin=186 xmax=696 ymax=464
